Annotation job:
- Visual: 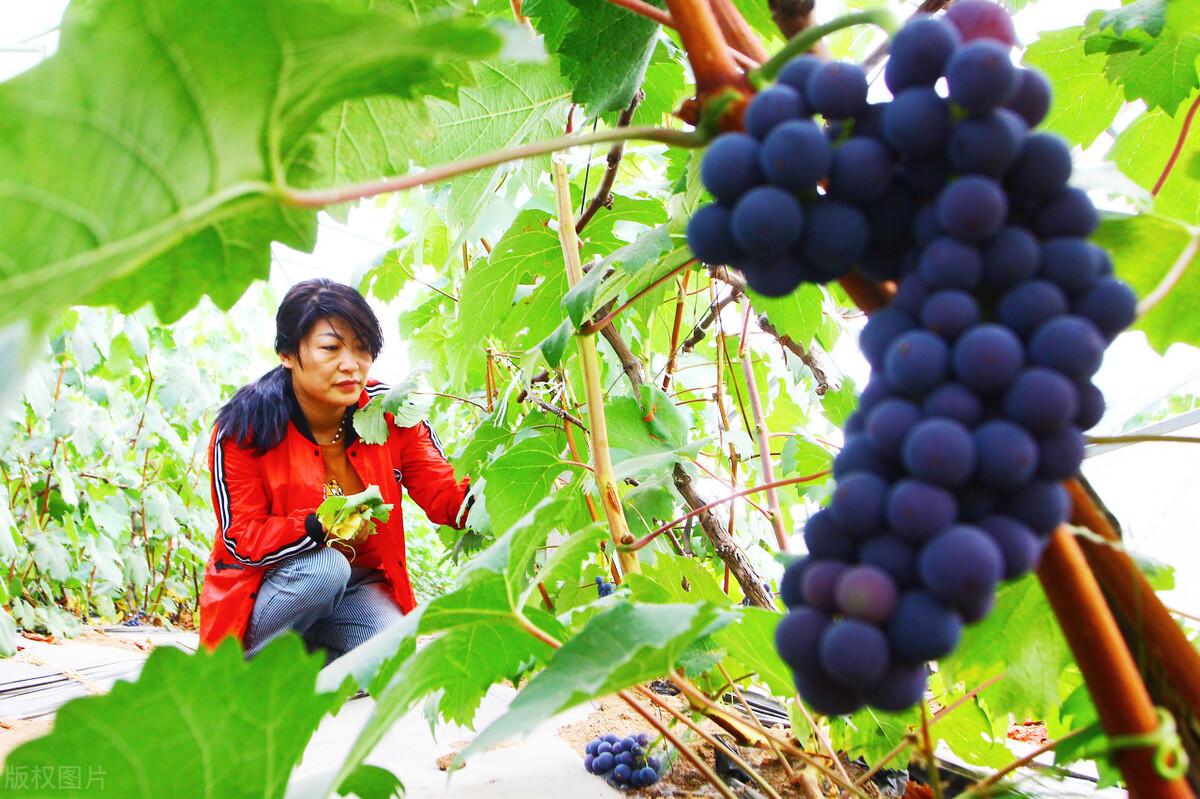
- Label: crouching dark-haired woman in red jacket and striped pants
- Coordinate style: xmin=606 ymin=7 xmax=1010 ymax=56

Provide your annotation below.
xmin=200 ymin=278 xmax=467 ymax=662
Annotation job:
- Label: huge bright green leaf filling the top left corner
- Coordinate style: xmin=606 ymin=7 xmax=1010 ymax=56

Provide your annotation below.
xmin=0 ymin=0 xmax=500 ymax=324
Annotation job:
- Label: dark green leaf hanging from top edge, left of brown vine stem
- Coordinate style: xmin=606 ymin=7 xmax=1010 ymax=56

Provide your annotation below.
xmin=521 ymin=0 xmax=659 ymax=116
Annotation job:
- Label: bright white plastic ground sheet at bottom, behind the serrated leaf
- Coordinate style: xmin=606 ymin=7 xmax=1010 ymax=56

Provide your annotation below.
xmin=286 ymin=685 xmax=623 ymax=799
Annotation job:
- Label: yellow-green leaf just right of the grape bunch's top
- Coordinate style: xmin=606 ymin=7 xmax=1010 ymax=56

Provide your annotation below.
xmin=1024 ymin=28 xmax=1122 ymax=148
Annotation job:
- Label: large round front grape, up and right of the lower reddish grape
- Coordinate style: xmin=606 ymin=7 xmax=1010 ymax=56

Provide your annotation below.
xmin=917 ymin=524 xmax=1004 ymax=608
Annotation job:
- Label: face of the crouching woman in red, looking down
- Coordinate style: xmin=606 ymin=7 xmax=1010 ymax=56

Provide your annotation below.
xmin=280 ymin=318 xmax=374 ymax=408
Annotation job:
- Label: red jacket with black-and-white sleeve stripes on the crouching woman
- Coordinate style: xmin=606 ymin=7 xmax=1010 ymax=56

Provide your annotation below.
xmin=200 ymin=380 xmax=468 ymax=649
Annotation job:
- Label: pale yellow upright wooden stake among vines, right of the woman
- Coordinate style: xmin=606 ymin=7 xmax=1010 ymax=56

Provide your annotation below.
xmin=551 ymin=158 xmax=641 ymax=575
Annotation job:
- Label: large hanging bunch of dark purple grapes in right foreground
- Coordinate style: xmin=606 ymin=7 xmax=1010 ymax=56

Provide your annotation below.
xmin=688 ymin=0 xmax=1135 ymax=714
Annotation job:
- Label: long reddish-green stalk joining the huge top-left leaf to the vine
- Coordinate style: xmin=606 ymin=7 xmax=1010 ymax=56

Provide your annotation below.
xmin=277 ymin=125 xmax=708 ymax=208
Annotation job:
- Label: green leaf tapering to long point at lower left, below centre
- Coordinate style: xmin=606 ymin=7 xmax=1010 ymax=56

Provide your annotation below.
xmin=458 ymin=602 xmax=737 ymax=761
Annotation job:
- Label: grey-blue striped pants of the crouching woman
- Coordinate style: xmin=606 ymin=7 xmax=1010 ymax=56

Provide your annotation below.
xmin=245 ymin=547 xmax=404 ymax=666
